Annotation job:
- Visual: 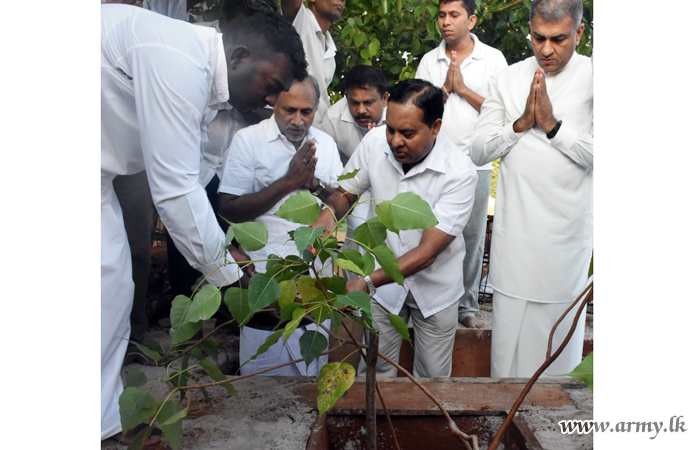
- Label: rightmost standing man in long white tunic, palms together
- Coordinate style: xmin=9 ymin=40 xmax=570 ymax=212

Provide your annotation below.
xmin=471 ymin=0 xmax=593 ymax=377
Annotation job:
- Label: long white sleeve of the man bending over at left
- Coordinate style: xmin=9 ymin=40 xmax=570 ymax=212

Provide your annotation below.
xmin=132 ymin=46 xmax=238 ymax=285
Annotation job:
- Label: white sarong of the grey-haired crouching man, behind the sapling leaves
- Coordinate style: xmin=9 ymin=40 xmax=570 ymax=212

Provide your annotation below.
xmin=240 ymin=319 xmax=331 ymax=376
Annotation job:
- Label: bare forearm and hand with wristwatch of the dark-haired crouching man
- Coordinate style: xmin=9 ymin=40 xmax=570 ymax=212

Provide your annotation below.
xmin=347 ymin=227 xmax=455 ymax=292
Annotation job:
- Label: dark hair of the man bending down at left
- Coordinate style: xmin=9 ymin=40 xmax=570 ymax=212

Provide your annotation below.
xmin=223 ymin=13 xmax=307 ymax=81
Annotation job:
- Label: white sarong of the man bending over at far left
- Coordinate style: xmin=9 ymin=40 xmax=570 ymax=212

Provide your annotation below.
xmin=100 ymin=181 xmax=134 ymax=439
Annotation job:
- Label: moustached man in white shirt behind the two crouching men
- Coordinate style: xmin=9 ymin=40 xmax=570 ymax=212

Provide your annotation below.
xmin=319 ymin=64 xmax=389 ymax=164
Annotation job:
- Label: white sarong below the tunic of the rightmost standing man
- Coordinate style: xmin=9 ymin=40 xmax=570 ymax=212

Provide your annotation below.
xmin=491 ymin=290 xmax=586 ymax=378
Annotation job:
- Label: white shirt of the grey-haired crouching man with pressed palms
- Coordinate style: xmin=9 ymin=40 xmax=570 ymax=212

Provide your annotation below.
xmin=219 ymin=116 xmax=343 ymax=272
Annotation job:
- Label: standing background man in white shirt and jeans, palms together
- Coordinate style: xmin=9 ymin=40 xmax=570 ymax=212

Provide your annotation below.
xmin=416 ymin=0 xmax=508 ymax=328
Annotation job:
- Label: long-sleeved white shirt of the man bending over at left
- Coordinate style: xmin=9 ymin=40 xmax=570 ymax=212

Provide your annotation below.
xmin=101 ymin=4 xmax=238 ymax=285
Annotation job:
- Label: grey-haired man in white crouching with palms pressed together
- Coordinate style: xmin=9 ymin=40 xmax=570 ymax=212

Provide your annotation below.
xmin=219 ymin=77 xmax=343 ymax=375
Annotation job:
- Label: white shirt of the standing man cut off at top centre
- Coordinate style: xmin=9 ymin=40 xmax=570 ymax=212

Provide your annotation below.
xmin=292 ymin=3 xmax=336 ymax=126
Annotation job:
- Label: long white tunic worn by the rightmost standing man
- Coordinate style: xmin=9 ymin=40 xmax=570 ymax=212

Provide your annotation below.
xmin=471 ymin=53 xmax=593 ymax=303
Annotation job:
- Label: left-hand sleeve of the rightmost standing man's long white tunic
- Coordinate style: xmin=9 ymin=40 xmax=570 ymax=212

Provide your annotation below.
xmin=469 ymin=77 xmax=524 ymax=166
